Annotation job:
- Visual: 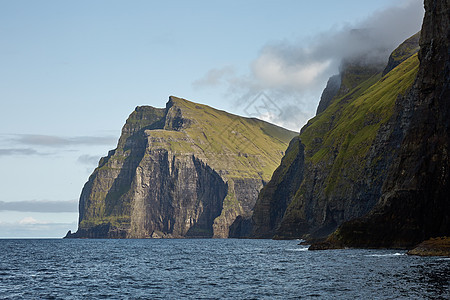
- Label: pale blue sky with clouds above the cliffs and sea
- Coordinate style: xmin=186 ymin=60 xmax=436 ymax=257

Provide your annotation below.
xmin=0 ymin=0 xmax=423 ymax=238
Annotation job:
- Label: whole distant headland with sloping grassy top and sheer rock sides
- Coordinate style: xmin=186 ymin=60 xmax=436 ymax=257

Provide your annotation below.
xmin=67 ymin=97 xmax=296 ymax=238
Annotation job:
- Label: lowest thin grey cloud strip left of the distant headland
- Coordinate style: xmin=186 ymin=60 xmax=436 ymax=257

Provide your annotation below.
xmin=0 ymin=200 xmax=78 ymax=213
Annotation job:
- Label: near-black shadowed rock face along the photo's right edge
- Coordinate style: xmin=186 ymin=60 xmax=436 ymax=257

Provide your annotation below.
xmin=316 ymin=0 xmax=450 ymax=248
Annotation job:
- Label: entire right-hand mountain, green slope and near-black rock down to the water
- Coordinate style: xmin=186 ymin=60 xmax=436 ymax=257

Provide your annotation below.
xmin=252 ymin=0 xmax=450 ymax=255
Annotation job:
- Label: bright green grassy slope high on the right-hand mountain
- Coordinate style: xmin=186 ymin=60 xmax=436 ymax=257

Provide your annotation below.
xmin=301 ymin=54 xmax=419 ymax=161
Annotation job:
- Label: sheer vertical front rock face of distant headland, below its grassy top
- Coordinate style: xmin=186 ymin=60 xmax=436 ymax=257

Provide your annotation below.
xmin=127 ymin=149 xmax=227 ymax=238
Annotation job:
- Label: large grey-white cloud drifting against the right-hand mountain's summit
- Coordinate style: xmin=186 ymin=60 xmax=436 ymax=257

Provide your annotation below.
xmin=193 ymin=0 xmax=424 ymax=130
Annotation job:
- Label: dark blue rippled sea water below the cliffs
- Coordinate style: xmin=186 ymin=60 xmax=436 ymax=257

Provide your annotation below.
xmin=0 ymin=239 xmax=450 ymax=299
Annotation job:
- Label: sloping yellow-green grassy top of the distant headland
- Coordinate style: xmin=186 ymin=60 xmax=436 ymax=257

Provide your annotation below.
xmin=134 ymin=96 xmax=298 ymax=181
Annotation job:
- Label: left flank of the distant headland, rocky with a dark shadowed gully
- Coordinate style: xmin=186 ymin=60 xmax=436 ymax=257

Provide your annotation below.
xmin=75 ymin=107 xmax=164 ymax=238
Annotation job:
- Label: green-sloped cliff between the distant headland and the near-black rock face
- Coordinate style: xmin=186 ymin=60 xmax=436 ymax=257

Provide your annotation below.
xmin=252 ymin=33 xmax=418 ymax=239
